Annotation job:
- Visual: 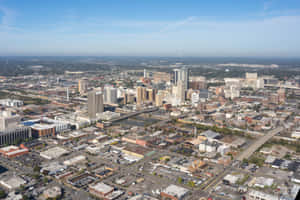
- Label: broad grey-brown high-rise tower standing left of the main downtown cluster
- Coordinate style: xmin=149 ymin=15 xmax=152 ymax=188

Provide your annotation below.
xmin=88 ymin=91 xmax=104 ymax=119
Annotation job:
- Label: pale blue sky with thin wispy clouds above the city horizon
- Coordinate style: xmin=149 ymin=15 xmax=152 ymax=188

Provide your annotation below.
xmin=0 ymin=0 xmax=300 ymax=57
